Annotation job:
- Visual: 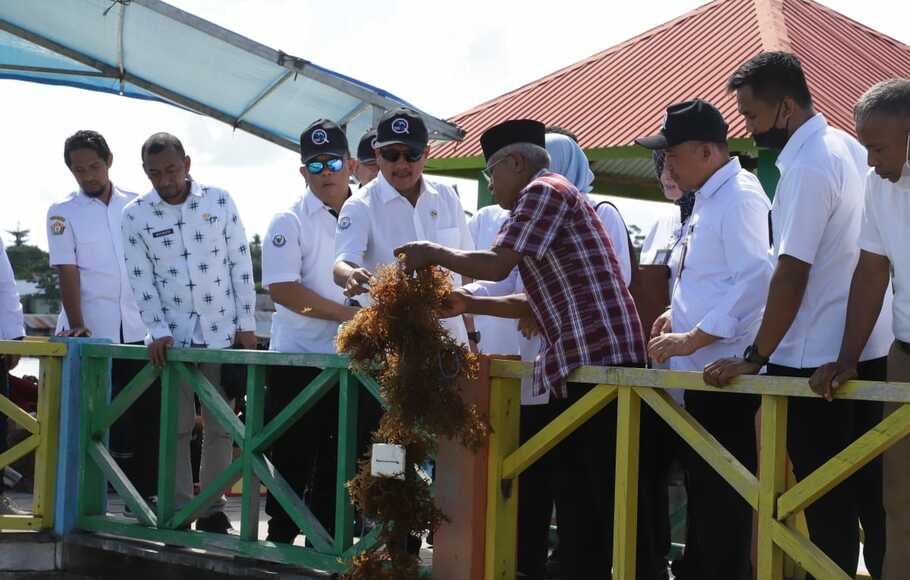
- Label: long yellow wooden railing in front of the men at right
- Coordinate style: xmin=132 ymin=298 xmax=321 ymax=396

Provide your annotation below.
xmin=485 ymin=360 xmax=910 ymax=580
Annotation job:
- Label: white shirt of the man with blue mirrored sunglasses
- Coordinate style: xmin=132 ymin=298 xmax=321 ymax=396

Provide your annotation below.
xmin=262 ymin=188 xmax=344 ymax=353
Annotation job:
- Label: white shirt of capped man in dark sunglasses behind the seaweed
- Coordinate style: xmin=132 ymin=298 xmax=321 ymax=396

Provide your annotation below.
xmin=335 ymin=172 xmax=474 ymax=343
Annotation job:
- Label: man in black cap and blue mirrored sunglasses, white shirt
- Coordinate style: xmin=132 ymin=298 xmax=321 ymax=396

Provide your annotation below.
xmin=262 ymin=119 xmax=376 ymax=543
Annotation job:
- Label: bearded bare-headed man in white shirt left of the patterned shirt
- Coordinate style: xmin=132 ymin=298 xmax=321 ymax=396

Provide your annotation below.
xmin=47 ymin=131 xmax=160 ymax=506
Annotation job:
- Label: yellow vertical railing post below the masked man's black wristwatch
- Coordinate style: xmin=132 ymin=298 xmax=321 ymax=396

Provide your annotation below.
xmin=756 ymin=395 xmax=787 ymax=580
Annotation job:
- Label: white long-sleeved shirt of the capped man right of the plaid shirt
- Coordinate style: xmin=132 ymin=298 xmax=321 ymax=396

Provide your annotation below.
xmin=669 ymin=158 xmax=772 ymax=372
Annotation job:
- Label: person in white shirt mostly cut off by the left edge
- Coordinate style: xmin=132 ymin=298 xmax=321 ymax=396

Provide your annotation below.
xmin=0 ymin=238 xmax=28 ymax=516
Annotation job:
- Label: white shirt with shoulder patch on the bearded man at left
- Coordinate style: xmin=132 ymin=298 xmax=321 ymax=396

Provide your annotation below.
xmin=47 ymin=186 xmax=147 ymax=343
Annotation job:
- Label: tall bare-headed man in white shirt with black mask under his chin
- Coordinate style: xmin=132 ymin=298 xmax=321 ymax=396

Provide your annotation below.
xmin=704 ymin=52 xmax=892 ymax=578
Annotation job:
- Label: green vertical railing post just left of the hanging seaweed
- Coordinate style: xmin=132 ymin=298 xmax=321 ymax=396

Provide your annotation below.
xmin=335 ymin=370 xmax=360 ymax=556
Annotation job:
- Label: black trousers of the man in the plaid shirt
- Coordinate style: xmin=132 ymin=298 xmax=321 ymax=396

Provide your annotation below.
xmin=548 ymin=383 xmax=667 ymax=580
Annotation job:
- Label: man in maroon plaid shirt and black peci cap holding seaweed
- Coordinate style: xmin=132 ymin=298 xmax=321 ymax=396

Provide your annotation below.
xmin=395 ymin=120 xmax=666 ymax=580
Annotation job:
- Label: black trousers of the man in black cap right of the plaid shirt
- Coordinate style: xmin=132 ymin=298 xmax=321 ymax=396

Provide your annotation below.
xmin=677 ymin=391 xmax=759 ymax=580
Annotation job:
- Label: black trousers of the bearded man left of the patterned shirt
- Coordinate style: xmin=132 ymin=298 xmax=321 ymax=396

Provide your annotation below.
xmin=110 ymin=343 xmax=161 ymax=497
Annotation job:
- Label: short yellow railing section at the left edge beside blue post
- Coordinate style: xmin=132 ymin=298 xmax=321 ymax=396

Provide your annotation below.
xmin=0 ymin=339 xmax=66 ymax=530
